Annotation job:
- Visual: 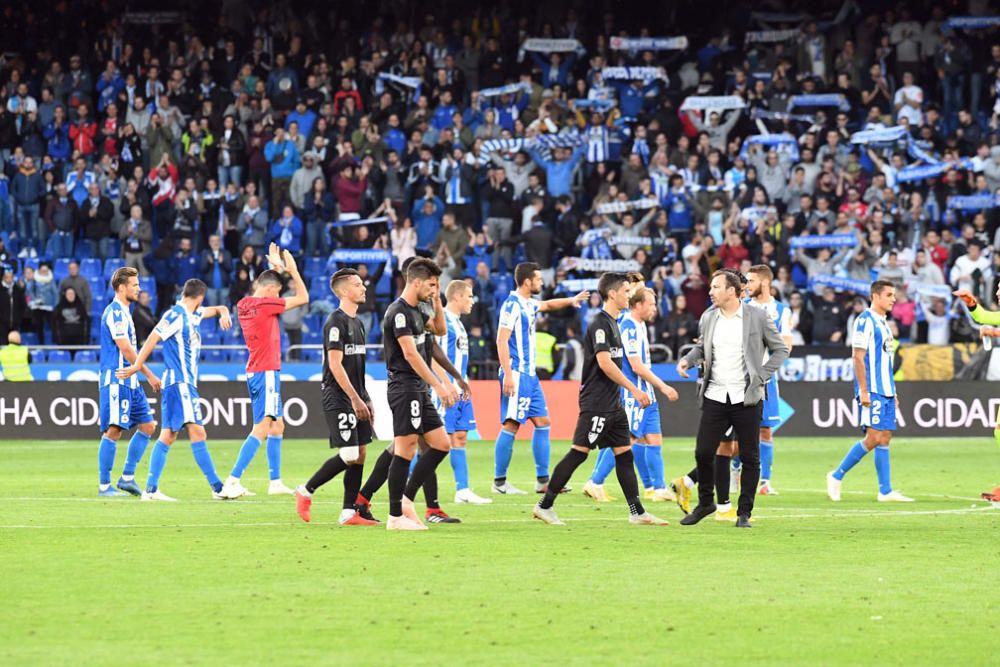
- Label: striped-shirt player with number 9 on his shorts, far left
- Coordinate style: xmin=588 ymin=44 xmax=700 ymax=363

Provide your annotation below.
xmin=97 ymin=267 xmax=160 ymax=497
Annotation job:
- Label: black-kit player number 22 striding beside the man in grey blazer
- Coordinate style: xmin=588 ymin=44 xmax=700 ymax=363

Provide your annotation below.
xmin=533 ymin=273 xmax=667 ymax=526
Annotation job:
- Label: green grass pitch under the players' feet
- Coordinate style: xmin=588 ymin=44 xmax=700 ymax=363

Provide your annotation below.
xmin=0 ymin=438 xmax=1000 ymax=666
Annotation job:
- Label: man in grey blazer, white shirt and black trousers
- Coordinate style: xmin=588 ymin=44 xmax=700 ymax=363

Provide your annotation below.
xmin=677 ymin=271 xmax=788 ymax=528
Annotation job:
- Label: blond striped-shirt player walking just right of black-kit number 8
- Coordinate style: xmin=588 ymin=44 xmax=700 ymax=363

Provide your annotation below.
xmin=433 ymin=280 xmax=493 ymax=505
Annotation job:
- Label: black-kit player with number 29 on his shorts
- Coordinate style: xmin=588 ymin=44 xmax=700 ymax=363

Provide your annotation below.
xmin=295 ymin=269 xmax=378 ymax=526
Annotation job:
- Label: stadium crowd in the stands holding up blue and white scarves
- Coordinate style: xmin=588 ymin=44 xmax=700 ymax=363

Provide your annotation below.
xmin=0 ymin=0 xmax=1000 ymax=368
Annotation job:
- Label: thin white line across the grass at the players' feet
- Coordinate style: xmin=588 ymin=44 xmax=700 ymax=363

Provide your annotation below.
xmin=0 ymin=506 xmax=993 ymax=530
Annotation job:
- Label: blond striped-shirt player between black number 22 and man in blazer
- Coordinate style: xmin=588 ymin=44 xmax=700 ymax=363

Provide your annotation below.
xmin=583 ymin=284 xmax=678 ymax=502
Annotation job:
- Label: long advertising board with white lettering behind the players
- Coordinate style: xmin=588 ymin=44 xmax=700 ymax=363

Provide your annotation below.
xmin=0 ymin=379 xmax=1000 ymax=441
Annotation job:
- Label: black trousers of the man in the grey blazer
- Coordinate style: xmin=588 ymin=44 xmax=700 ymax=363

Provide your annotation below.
xmin=694 ymin=397 xmax=761 ymax=516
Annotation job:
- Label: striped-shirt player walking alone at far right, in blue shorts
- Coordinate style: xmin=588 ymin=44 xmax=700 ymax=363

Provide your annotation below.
xmin=826 ymin=280 xmax=913 ymax=503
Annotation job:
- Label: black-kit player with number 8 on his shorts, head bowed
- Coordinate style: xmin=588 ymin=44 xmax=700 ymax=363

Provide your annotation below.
xmin=382 ymin=258 xmax=458 ymax=530
